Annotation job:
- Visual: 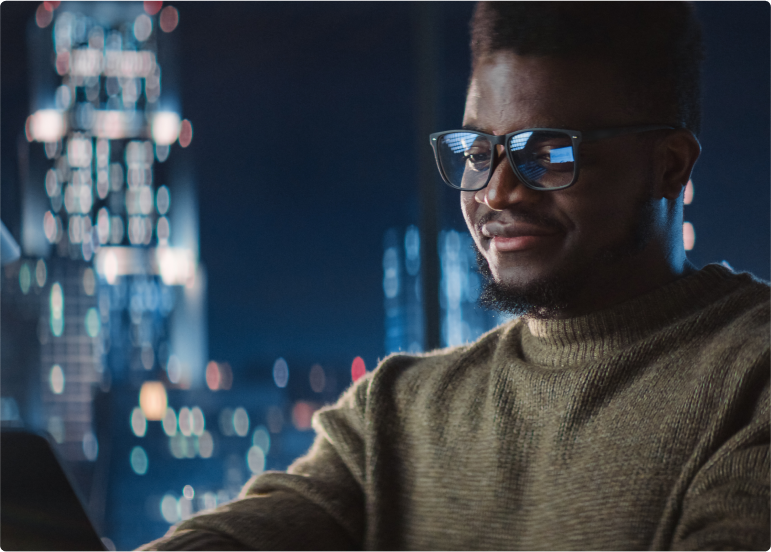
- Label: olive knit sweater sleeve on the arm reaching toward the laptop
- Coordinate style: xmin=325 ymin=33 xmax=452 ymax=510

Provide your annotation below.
xmin=133 ymin=377 xmax=369 ymax=552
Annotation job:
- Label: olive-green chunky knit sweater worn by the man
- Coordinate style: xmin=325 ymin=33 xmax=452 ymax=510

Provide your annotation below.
xmin=137 ymin=265 xmax=771 ymax=552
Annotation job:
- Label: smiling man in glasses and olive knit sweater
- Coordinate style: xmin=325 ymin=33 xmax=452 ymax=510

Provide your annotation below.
xmin=139 ymin=0 xmax=771 ymax=552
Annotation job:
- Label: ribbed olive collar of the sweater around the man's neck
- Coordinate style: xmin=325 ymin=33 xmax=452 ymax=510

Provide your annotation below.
xmin=520 ymin=264 xmax=738 ymax=368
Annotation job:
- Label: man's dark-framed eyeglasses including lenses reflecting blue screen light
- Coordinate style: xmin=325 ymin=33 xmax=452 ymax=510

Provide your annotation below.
xmin=430 ymin=125 xmax=674 ymax=192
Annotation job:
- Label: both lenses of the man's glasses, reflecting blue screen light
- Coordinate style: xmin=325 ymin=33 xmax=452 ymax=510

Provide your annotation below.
xmin=437 ymin=130 xmax=575 ymax=190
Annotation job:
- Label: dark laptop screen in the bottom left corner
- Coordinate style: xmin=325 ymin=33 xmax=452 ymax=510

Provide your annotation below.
xmin=0 ymin=430 xmax=107 ymax=552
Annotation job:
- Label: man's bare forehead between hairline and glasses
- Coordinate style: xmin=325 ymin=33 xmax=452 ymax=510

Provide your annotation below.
xmin=463 ymin=52 xmax=635 ymax=134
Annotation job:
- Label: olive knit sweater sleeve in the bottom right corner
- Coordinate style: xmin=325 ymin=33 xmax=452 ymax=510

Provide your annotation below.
xmin=671 ymin=401 xmax=771 ymax=552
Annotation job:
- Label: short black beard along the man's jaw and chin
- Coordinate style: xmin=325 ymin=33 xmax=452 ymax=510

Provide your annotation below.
xmin=471 ymin=181 xmax=656 ymax=319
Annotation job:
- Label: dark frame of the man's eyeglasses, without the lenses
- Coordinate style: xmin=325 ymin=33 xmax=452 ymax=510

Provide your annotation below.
xmin=429 ymin=125 xmax=678 ymax=192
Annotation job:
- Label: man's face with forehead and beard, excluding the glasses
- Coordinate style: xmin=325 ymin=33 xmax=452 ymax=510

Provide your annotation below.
xmin=461 ymin=52 xmax=664 ymax=316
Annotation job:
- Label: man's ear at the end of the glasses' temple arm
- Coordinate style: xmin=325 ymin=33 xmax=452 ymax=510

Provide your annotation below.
xmin=657 ymin=128 xmax=701 ymax=200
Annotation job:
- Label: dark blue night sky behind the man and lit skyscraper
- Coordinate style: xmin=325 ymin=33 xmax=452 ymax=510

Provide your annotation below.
xmin=0 ymin=0 xmax=771 ymax=384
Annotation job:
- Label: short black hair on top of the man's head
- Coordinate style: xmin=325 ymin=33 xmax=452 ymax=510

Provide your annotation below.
xmin=471 ymin=0 xmax=704 ymax=135
